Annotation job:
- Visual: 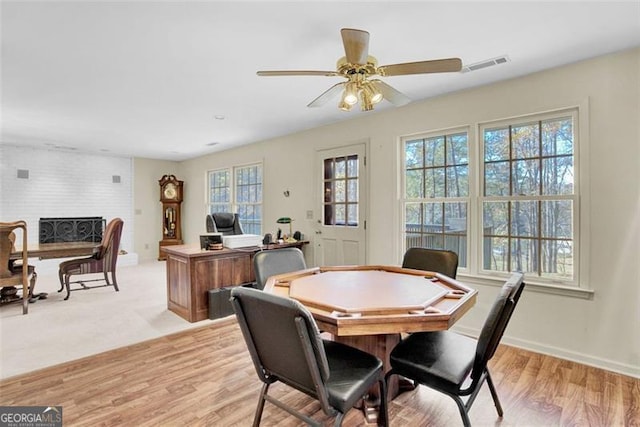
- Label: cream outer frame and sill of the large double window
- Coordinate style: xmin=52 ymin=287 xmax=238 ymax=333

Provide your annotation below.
xmin=398 ymin=105 xmax=594 ymax=292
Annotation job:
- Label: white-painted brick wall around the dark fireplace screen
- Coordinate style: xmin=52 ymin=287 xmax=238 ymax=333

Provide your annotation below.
xmin=0 ymin=145 xmax=133 ymax=252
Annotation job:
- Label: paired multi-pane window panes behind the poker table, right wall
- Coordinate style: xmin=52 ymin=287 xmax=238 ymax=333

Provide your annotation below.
xmin=402 ymin=109 xmax=579 ymax=285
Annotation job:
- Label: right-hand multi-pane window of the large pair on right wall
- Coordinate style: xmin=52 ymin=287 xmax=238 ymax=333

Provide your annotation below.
xmin=480 ymin=115 xmax=576 ymax=280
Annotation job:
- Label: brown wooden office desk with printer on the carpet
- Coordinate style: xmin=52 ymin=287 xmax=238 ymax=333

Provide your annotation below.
xmin=162 ymin=241 xmax=308 ymax=322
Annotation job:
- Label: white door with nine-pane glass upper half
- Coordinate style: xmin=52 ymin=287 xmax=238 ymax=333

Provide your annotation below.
xmin=314 ymin=143 xmax=367 ymax=266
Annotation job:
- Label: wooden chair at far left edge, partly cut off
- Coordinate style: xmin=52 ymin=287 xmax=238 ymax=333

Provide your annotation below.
xmin=0 ymin=220 xmax=36 ymax=314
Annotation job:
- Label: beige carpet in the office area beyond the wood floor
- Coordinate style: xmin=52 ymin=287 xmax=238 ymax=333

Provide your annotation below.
xmin=0 ymin=261 xmax=220 ymax=378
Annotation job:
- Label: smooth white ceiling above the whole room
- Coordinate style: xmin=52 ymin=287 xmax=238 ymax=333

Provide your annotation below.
xmin=0 ymin=0 xmax=640 ymax=160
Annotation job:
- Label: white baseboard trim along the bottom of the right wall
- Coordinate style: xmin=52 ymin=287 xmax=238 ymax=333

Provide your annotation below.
xmin=454 ymin=326 xmax=640 ymax=378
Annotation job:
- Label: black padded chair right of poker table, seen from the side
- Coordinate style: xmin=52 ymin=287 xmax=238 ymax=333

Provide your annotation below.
xmin=386 ymin=273 xmax=525 ymax=427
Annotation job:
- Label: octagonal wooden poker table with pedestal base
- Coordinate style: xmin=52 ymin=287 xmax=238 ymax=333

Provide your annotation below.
xmin=264 ymin=265 xmax=477 ymax=412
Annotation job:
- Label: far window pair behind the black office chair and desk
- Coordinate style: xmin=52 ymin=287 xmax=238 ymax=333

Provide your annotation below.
xmin=207 ymin=164 xmax=262 ymax=234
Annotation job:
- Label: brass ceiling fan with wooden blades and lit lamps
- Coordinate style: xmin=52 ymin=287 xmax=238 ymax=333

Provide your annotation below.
xmin=257 ymin=28 xmax=462 ymax=111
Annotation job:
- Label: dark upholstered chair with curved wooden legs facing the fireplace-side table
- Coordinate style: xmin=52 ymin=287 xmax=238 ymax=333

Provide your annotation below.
xmin=58 ymin=218 xmax=124 ymax=300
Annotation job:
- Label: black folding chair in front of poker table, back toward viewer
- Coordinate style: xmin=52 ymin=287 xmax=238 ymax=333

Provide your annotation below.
xmin=231 ymin=287 xmax=389 ymax=426
